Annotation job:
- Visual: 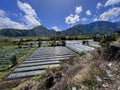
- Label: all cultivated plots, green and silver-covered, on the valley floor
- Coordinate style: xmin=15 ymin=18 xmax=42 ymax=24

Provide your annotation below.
xmin=0 ymin=38 xmax=99 ymax=79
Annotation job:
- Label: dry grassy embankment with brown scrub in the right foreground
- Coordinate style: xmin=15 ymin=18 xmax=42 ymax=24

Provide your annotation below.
xmin=2 ymin=46 xmax=120 ymax=90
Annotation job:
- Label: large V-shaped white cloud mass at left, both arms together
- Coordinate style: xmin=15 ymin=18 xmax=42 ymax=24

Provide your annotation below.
xmin=0 ymin=0 xmax=41 ymax=29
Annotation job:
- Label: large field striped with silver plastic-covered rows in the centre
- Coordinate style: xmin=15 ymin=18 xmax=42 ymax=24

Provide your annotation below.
xmin=6 ymin=47 xmax=76 ymax=79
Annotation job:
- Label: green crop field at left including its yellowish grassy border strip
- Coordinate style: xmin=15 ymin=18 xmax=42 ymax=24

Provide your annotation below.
xmin=0 ymin=42 xmax=36 ymax=80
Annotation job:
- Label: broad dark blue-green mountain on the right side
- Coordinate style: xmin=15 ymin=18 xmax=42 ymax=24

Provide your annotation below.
xmin=62 ymin=21 xmax=120 ymax=36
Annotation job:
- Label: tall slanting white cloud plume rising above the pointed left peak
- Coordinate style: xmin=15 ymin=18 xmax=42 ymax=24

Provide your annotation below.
xmin=17 ymin=0 xmax=41 ymax=28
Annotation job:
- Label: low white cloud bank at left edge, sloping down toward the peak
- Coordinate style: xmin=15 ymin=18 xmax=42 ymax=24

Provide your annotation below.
xmin=0 ymin=10 xmax=27 ymax=29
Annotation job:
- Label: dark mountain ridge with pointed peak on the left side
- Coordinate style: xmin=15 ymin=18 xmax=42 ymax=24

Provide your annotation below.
xmin=0 ymin=25 xmax=52 ymax=37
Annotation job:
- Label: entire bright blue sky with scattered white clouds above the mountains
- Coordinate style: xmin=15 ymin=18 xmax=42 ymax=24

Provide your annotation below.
xmin=0 ymin=0 xmax=120 ymax=31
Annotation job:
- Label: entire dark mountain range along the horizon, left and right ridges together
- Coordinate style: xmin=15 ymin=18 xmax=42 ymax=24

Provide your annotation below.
xmin=0 ymin=21 xmax=120 ymax=37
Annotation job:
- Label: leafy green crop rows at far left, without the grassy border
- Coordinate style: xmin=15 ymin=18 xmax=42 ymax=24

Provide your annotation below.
xmin=0 ymin=46 xmax=32 ymax=69
